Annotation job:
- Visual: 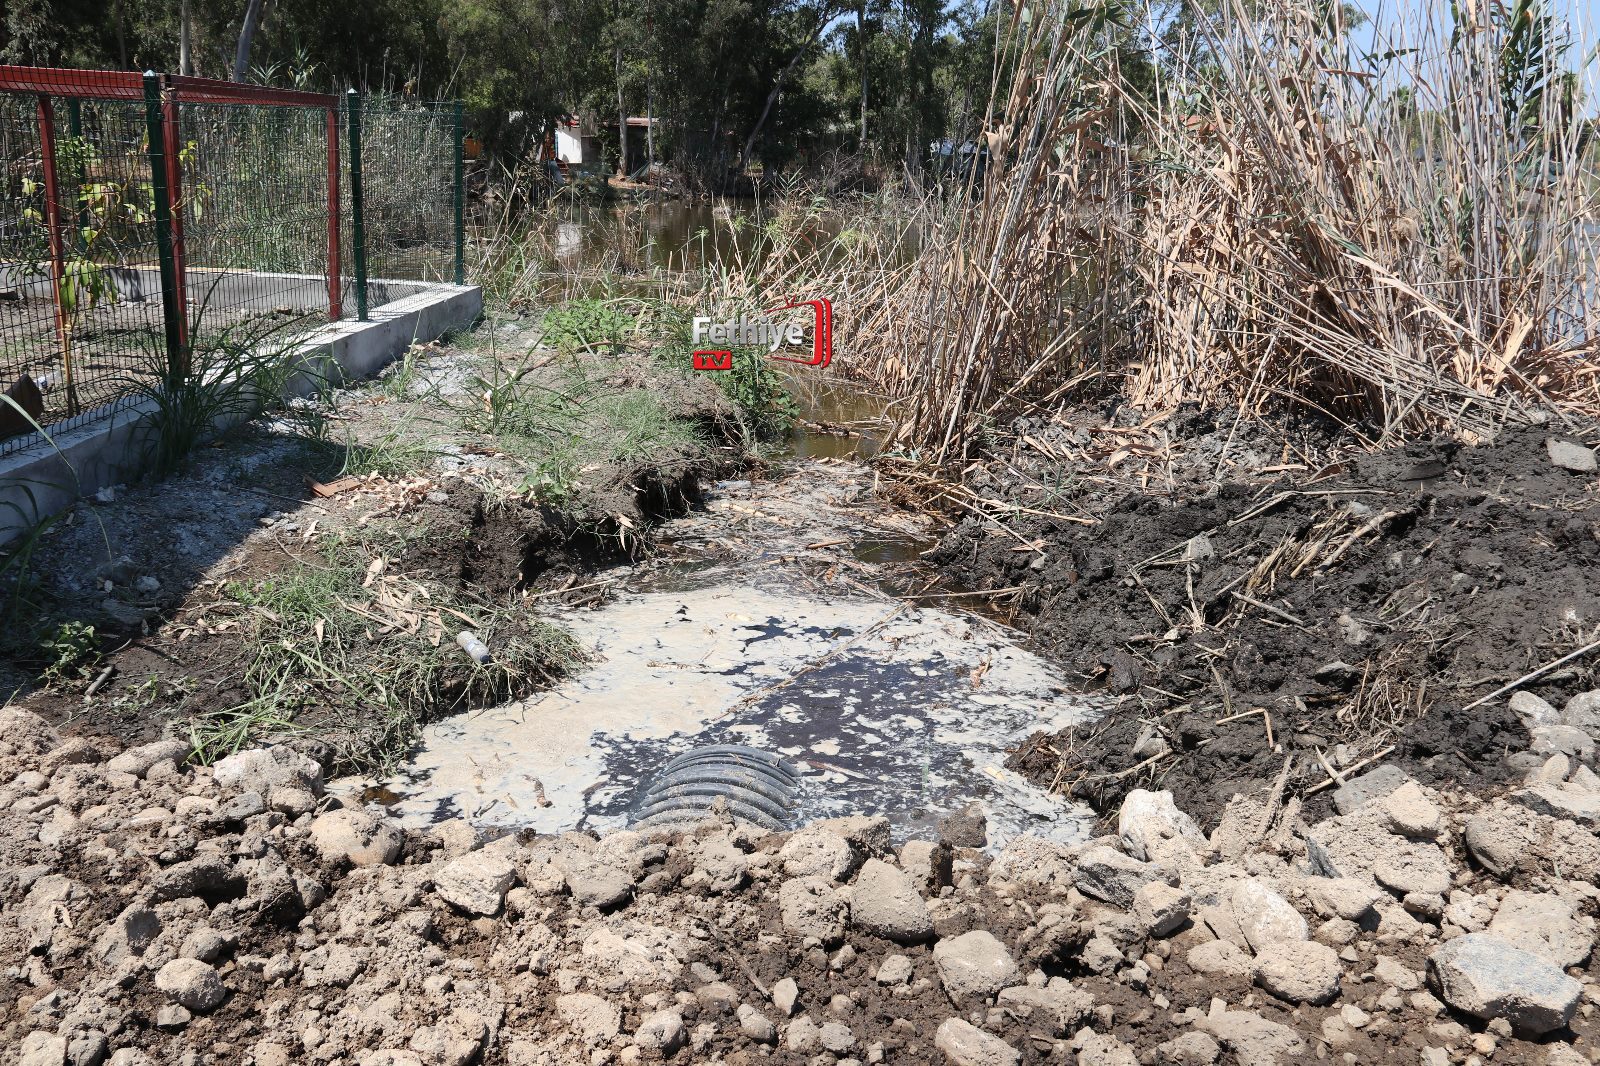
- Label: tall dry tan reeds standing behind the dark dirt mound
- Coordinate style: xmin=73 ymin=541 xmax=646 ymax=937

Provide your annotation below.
xmin=700 ymin=0 xmax=1600 ymax=463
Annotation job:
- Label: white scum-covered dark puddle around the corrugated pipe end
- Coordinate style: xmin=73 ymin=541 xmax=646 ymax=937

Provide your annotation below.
xmin=346 ymin=584 xmax=1096 ymax=847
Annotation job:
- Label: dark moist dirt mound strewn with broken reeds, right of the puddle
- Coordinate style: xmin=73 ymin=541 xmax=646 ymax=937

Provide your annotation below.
xmin=934 ymin=429 xmax=1600 ymax=824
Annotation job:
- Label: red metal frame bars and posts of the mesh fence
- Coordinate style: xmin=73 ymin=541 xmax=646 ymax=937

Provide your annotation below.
xmin=0 ymin=66 xmax=344 ymax=340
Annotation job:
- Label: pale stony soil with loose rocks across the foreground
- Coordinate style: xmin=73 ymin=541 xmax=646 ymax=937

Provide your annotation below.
xmin=0 ymin=694 xmax=1600 ymax=1066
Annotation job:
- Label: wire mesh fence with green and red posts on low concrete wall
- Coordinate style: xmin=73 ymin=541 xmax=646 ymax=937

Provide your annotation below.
xmin=0 ymin=66 xmax=462 ymax=455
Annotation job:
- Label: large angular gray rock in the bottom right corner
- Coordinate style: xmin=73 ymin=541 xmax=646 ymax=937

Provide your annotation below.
xmin=1427 ymin=933 xmax=1582 ymax=1036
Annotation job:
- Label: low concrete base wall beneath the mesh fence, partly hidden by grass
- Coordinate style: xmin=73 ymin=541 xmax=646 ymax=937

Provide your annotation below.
xmin=0 ymin=282 xmax=483 ymax=544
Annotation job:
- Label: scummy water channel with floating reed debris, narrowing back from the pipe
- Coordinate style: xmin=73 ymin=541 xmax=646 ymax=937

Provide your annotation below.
xmin=338 ymin=387 xmax=1098 ymax=847
